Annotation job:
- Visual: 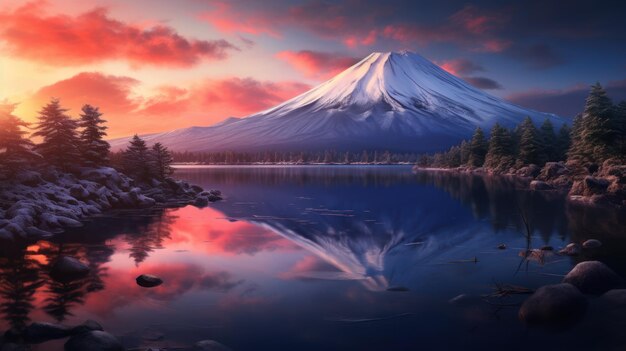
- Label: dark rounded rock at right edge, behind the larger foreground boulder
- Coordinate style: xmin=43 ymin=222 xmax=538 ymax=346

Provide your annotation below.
xmin=563 ymin=261 xmax=624 ymax=295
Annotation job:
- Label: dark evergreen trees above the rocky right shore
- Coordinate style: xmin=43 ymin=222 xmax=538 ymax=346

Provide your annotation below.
xmin=417 ymin=83 xmax=626 ymax=172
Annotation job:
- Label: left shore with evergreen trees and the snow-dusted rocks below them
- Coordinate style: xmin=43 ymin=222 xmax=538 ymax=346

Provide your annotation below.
xmin=0 ymin=99 xmax=221 ymax=242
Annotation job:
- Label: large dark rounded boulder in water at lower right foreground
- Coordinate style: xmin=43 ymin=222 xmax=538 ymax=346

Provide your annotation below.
xmin=519 ymin=283 xmax=587 ymax=328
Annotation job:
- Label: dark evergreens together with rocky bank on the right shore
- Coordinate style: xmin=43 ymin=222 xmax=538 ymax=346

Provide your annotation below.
xmin=416 ymin=84 xmax=626 ymax=207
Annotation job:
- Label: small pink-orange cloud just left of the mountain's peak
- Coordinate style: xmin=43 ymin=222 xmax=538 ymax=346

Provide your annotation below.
xmin=276 ymin=50 xmax=358 ymax=78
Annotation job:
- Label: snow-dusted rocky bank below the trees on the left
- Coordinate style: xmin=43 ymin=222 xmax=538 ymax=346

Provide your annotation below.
xmin=0 ymin=167 xmax=221 ymax=242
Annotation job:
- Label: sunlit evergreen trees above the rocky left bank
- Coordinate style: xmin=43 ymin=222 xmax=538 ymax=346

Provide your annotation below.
xmin=0 ymin=99 xmax=172 ymax=181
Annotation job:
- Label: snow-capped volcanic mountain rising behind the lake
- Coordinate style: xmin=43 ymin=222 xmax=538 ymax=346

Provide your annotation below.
xmin=112 ymin=52 xmax=562 ymax=152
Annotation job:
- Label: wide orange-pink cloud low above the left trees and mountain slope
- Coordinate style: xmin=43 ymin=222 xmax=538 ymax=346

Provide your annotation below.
xmin=18 ymin=72 xmax=310 ymax=137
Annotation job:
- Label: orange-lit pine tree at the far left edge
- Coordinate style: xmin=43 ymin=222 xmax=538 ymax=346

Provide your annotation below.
xmin=0 ymin=104 xmax=38 ymax=177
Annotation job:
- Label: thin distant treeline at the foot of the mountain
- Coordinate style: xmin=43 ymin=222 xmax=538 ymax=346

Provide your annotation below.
xmin=172 ymin=150 xmax=419 ymax=165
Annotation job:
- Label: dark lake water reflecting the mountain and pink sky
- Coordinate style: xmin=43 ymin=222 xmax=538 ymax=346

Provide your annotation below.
xmin=0 ymin=166 xmax=626 ymax=351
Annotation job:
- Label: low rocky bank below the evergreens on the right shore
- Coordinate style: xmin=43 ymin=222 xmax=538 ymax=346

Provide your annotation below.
xmin=413 ymin=160 xmax=626 ymax=208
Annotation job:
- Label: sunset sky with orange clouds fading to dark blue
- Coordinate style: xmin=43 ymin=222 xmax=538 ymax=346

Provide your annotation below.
xmin=0 ymin=0 xmax=626 ymax=137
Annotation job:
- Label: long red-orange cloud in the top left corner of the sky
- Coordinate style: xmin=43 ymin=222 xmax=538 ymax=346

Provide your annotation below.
xmin=0 ymin=2 xmax=237 ymax=67
